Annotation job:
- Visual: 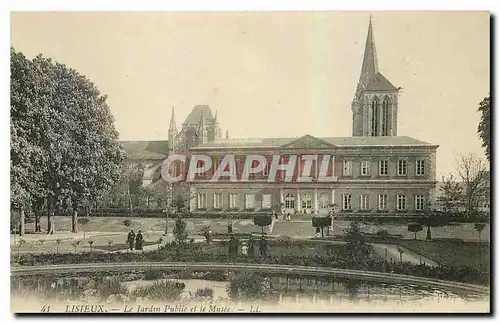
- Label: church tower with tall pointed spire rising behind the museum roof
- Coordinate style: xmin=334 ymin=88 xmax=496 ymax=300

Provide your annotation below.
xmin=352 ymin=16 xmax=399 ymax=137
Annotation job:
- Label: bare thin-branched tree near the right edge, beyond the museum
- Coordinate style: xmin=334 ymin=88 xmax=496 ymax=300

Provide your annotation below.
xmin=457 ymin=154 xmax=489 ymax=215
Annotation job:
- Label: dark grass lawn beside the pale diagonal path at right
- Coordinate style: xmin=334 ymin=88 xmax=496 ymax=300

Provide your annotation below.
xmin=399 ymin=240 xmax=490 ymax=267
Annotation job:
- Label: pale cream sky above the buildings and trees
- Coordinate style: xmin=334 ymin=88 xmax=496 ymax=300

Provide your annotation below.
xmin=11 ymin=12 xmax=490 ymax=178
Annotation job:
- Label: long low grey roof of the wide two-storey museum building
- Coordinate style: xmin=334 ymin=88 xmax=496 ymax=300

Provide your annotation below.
xmin=194 ymin=135 xmax=437 ymax=149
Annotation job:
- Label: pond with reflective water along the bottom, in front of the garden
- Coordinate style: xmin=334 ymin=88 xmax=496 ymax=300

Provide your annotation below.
xmin=11 ymin=273 xmax=489 ymax=312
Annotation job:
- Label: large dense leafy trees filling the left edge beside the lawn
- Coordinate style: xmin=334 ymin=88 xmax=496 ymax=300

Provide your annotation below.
xmin=10 ymin=48 xmax=124 ymax=232
